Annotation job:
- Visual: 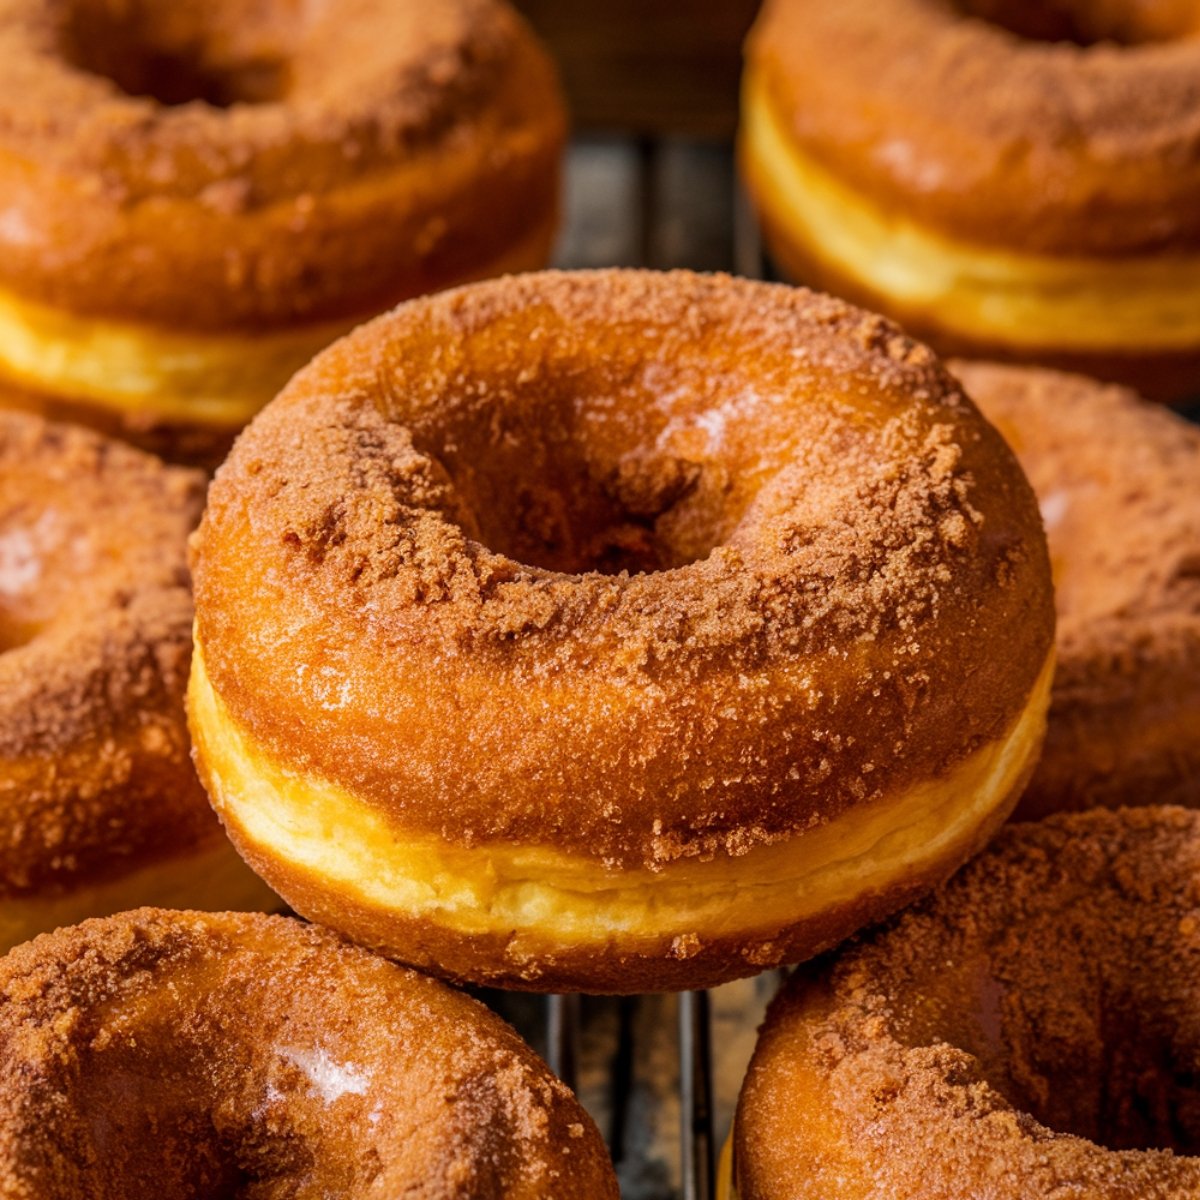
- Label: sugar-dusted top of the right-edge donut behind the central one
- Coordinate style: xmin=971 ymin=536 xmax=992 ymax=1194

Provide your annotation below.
xmin=950 ymin=361 xmax=1200 ymax=701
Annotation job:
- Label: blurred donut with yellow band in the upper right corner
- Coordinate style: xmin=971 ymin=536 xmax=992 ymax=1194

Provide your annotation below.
xmin=740 ymin=0 xmax=1200 ymax=400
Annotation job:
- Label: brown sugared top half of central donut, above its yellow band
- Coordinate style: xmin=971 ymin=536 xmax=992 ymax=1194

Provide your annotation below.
xmin=193 ymin=271 xmax=1052 ymax=868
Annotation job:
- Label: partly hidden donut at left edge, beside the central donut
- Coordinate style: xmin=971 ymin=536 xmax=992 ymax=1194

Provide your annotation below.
xmin=0 ymin=410 xmax=278 ymax=955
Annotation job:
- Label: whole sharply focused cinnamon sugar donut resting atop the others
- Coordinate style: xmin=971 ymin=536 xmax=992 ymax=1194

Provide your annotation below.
xmin=182 ymin=271 xmax=1052 ymax=991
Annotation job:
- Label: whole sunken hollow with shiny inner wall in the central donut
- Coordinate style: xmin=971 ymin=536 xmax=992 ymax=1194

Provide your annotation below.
xmin=380 ymin=314 xmax=823 ymax=575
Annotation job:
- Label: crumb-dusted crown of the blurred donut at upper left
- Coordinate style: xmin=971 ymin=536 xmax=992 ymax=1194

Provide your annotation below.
xmin=0 ymin=0 xmax=525 ymax=200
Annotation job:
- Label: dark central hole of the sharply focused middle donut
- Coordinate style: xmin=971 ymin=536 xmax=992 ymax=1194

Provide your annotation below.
xmin=408 ymin=384 xmax=787 ymax=575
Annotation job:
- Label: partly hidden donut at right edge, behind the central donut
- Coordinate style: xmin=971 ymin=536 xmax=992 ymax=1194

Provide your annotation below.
xmin=950 ymin=362 xmax=1200 ymax=818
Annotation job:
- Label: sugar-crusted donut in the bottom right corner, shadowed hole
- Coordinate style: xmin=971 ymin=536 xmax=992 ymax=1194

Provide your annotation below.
xmin=734 ymin=808 xmax=1200 ymax=1200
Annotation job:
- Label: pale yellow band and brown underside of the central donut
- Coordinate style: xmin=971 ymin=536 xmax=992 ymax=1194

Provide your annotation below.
xmin=188 ymin=643 xmax=1052 ymax=992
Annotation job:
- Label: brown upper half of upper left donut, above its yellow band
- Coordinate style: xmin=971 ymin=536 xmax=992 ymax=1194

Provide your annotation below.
xmin=0 ymin=0 xmax=562 ymax=330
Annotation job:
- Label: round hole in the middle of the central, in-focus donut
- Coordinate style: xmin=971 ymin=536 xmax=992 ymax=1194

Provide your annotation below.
xmin=385 ymin=357 xmax=785 ymax=575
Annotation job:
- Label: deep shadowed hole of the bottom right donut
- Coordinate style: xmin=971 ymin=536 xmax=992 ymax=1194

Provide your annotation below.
xmin=902 ymin=907 xmax=1200 ymax=1156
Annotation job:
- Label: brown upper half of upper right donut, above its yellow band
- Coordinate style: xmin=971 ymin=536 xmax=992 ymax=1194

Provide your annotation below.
xmin=748 ymin=0 xmax=1200 ymax=256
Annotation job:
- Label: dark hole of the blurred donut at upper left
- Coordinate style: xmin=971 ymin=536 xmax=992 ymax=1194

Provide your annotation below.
xmin=62 ymin=0 xmax=296 ymax=108
